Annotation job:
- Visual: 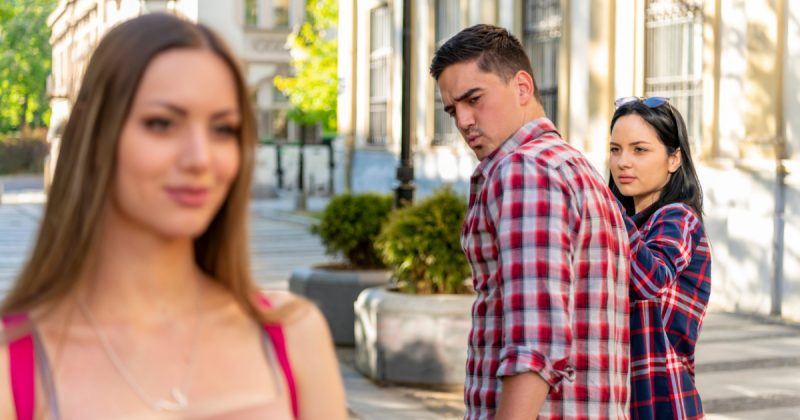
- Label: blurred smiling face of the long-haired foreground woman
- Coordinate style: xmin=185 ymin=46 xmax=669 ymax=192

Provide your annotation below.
xmin=113 ymin=49 xmax=241 ymax=238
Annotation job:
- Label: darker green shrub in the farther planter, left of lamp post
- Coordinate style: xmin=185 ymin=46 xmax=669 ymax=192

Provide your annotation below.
xmin=311 ymin=194 xmax=392 ymax=268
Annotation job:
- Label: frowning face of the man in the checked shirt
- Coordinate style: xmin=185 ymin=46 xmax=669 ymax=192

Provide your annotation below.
xmin=439 ymin=60 xmax=527 ymax=160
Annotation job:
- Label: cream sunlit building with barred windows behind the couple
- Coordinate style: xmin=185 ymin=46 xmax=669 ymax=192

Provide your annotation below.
xmin=339 ymin=0 xmax=800 ymax=320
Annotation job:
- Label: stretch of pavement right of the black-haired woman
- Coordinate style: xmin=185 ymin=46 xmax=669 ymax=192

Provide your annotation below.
xmin=696 ymin=313 xmax=800 ymax=420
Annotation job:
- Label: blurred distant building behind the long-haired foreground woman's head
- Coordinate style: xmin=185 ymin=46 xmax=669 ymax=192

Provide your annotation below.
xmin=47 ymin=0 xmax=329 ymax=197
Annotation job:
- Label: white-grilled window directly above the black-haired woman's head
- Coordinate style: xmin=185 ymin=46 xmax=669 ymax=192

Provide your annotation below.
xmin=645 ymin=0 xmax=703 ymax=146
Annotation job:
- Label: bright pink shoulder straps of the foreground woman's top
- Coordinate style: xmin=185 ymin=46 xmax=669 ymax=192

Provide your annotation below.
xmin=2 ymin=295 xmax=297 ymax=420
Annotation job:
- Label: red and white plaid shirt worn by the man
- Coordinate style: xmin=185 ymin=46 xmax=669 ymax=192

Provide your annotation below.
xmin=461 ymin=119 xmax=630 ymax=420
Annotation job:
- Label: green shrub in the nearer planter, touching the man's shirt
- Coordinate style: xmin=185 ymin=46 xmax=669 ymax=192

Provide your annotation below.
xmin=375 ymin=187 xmax=470 ymax=294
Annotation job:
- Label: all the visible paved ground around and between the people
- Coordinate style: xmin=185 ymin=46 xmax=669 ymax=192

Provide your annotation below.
xmin=0 ymin=197 xmax=800 ymax=420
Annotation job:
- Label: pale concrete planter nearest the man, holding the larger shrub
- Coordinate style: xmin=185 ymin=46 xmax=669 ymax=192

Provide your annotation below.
xmin=355 ymin=287 xmax=475 ymax=385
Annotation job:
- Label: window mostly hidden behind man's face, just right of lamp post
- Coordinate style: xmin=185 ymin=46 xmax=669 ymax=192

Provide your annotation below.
xmin=431 ymin=0 xmax=462 ymax=146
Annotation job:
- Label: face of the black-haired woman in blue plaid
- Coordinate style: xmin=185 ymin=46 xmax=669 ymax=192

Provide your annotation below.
xmin=609 ymin=115 xmax=681 ymax=213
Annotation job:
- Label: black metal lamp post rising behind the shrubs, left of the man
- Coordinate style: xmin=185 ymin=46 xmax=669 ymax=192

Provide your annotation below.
xmin=394 ymin=0 xmax=417 ymax=208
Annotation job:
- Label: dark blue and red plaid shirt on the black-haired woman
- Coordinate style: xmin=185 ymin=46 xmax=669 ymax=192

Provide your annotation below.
xmin=622 ymin=203 xmax=711 ymax=420
